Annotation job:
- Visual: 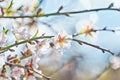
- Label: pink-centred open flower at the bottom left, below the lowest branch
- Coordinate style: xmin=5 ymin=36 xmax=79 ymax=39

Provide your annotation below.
xmin=12 ymin=67 xmax=24 ymax=80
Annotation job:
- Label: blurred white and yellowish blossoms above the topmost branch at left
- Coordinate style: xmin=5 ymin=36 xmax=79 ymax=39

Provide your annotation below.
xmin=0 ymin=0 xmax=42 ymax=16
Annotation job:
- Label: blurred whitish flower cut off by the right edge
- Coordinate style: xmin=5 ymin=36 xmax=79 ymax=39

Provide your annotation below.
xmin=110 ymin=56 xmax=120 ymax=70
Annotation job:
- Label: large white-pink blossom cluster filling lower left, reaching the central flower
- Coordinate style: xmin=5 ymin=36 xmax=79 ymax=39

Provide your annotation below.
xmin=0 ymin=27 xmax=72 ymax=80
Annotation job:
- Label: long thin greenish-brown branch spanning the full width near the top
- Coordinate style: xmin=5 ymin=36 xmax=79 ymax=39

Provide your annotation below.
xmin=0 ymin=8 xmax=120 ymax=18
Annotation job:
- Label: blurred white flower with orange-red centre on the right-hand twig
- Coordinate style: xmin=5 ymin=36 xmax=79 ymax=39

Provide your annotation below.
xmin=76 ymin=20 xmax=99 ymax=42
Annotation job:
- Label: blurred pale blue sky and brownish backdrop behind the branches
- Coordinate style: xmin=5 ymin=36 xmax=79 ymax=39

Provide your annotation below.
xmin=0 ymin=0 xmax=120 ymax=80
